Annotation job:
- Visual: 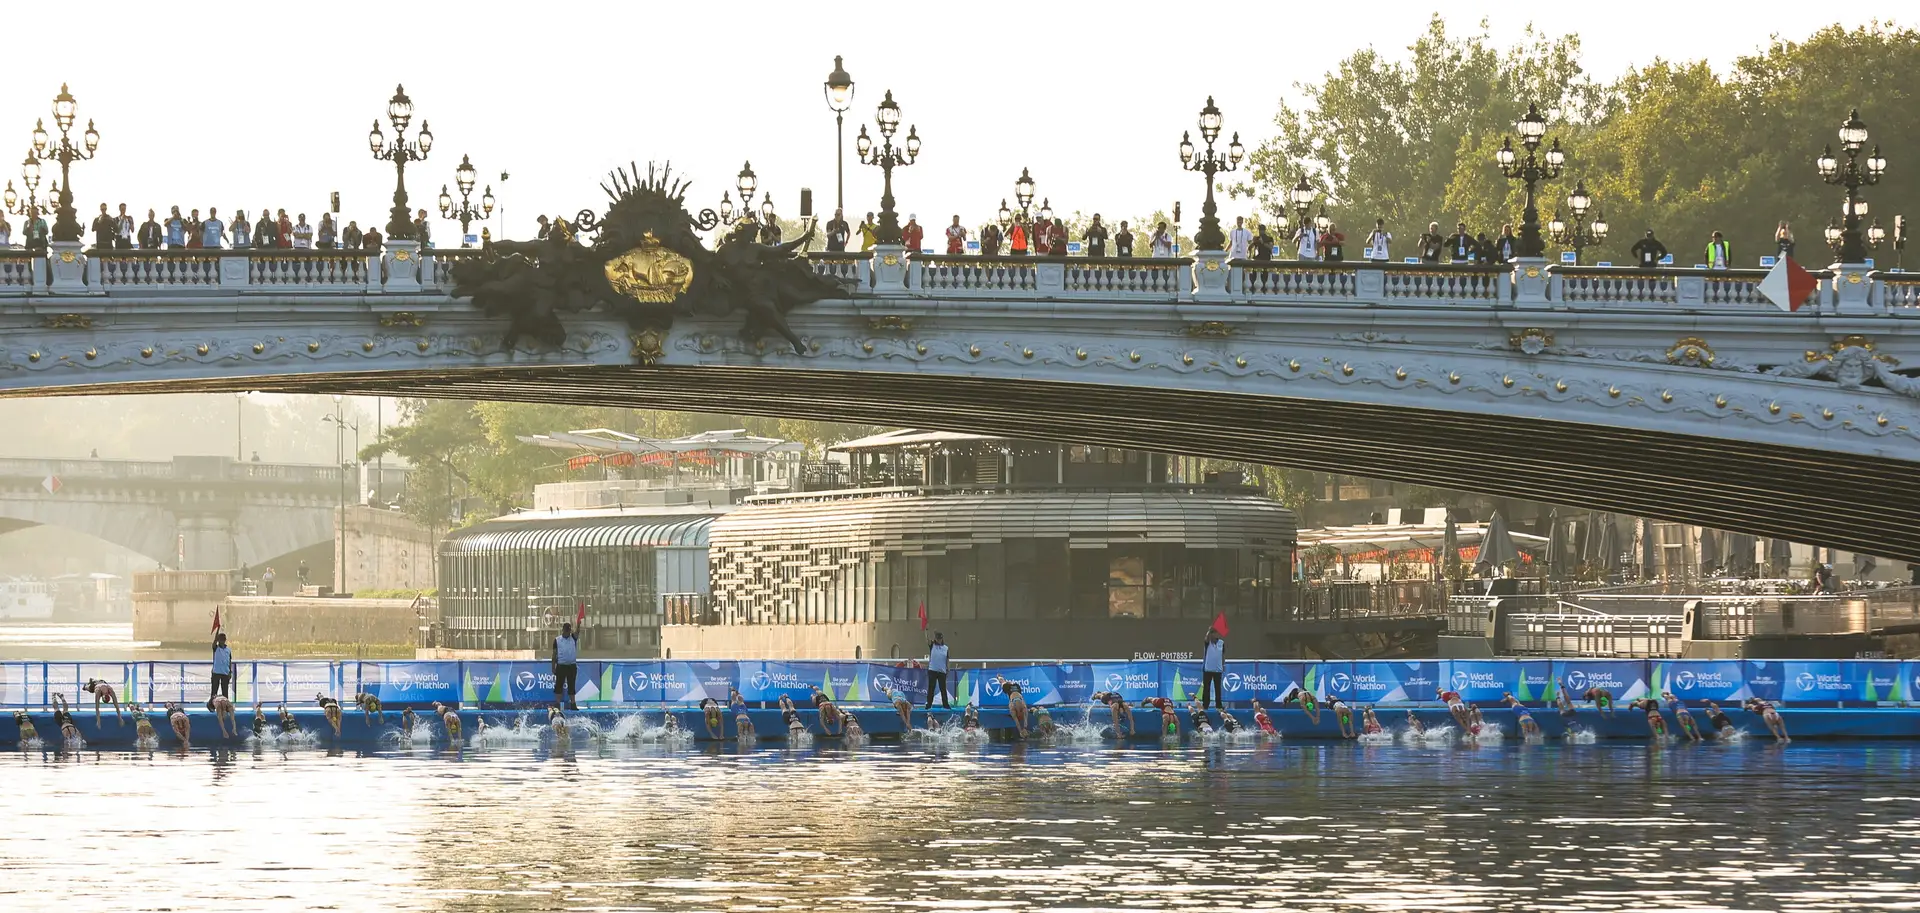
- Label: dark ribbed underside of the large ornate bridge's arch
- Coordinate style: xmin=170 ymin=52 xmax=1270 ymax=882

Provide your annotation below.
xmin=18 ymin=366 xmax=1920 ymax=560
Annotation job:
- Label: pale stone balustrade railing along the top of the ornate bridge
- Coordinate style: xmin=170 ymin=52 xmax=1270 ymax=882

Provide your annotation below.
xmin=0 ymin=242 xmax=1920 ymax=316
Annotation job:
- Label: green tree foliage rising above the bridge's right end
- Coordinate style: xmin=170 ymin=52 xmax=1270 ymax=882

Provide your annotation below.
xmin=1231 ymin=17 xmax=1920 ymax=265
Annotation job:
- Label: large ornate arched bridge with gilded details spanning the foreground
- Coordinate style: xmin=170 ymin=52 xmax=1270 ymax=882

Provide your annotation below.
xmin=11 ymin=242 xmax=1920 ymax=560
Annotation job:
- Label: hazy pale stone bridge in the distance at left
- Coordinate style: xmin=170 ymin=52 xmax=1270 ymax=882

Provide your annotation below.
xmin=0 ymin=457 xmax=340 ymax=570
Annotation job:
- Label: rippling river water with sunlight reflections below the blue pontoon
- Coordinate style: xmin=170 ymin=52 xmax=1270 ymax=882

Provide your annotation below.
xmin=0 ymin=738 xmax=1920 ymax=911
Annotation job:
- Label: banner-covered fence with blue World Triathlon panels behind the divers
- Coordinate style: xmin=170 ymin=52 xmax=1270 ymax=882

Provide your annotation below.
xmin=0 ymin=660 xmax=1920 ymax=708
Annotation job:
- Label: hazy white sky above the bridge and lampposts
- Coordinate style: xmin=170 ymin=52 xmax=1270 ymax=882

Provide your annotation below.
xmin=0 ymin=0 xmax=1889 ymax=242
